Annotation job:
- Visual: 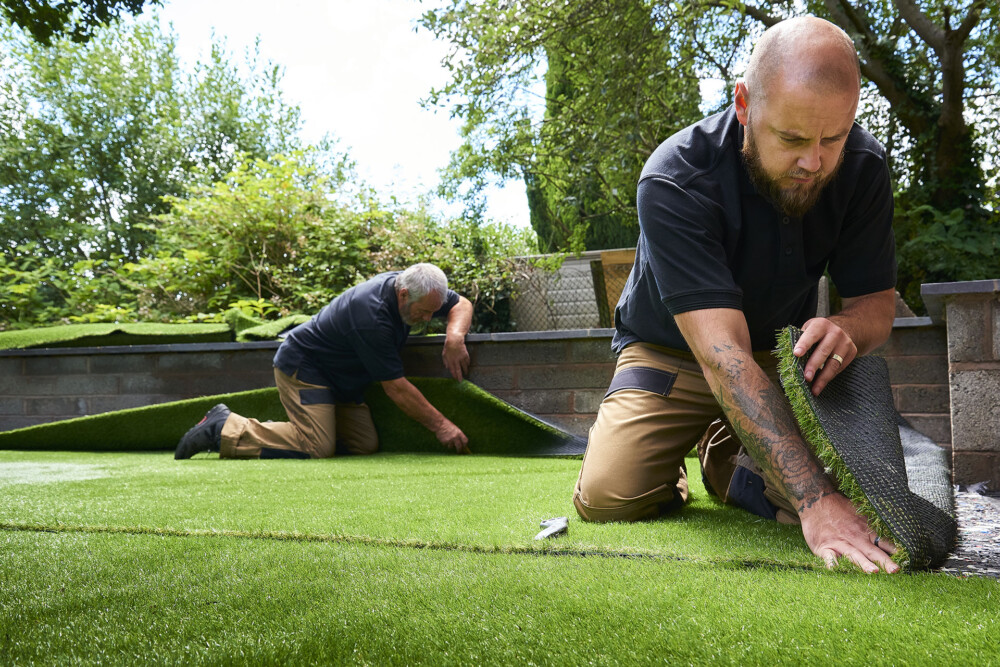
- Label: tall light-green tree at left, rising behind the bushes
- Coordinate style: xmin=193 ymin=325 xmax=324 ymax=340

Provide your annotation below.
xmin=0 ymin=16 xmax=316 ymax=266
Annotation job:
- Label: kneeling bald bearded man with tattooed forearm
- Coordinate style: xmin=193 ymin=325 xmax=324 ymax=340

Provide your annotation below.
xmin=573 ymin=17 xmax=898 ymax=572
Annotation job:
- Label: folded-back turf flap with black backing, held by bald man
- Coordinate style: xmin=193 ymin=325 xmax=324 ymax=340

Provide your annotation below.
xmin=775 ymin=327 xmax=958 ymax=569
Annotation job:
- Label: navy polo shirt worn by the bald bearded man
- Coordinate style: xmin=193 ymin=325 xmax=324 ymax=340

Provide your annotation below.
xmin=612 ymin=107 xmax=896 ymax=353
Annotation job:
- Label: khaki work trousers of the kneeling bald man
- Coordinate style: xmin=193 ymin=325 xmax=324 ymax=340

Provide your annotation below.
xmin=573 ymin=343 xmax=798 ymax=523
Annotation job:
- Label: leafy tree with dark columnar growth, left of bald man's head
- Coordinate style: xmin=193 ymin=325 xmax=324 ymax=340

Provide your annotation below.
xmin=422 ymin=0 xmax=700 ymax=249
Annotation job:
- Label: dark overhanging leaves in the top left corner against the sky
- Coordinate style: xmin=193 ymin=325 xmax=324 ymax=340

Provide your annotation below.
xmin=0 ymin=0 xmax=160 ymax=46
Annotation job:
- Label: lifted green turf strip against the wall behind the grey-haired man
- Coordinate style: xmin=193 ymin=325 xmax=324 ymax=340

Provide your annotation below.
xmin=0 ymin=378 xmax=566 ymax=455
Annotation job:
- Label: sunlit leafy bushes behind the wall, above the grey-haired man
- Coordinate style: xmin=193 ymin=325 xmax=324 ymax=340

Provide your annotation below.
xmin=0 ymin=153 xmax=537 ymax=331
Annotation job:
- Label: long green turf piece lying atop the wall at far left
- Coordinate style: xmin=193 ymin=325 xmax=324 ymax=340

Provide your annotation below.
xmin=0 ymin=322 xmax=233 ymax=350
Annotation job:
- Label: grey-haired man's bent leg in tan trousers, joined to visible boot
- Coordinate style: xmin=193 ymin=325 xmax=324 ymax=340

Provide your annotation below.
xmin=220 ymin=368 xmax=336 ymax=459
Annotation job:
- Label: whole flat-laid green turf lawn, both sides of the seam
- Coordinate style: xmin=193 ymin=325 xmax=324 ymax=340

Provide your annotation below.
xmin=0 ymin=451 xmax=1000 ymax=665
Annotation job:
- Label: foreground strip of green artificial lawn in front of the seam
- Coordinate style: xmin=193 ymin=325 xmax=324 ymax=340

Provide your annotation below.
xmin=0 ymin=532 xmax=1000 ymax=665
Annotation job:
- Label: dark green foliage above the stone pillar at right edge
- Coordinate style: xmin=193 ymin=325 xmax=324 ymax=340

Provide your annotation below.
xmin=894 ymin=197 xmax=1000 ymax=310
